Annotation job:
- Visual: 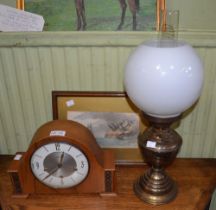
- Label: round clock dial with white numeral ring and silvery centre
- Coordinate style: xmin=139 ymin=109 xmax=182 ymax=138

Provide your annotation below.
xmin=31 ymin=142 xmax=89 ymax=189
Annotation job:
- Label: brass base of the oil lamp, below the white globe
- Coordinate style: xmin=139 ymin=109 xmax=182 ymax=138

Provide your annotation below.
xmin=134 ymin=114 xmax=182 ymax=205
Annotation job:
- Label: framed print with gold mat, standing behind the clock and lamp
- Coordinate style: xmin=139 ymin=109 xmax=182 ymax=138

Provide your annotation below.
xmin=52 ymin=91 xmax=146 ymax=164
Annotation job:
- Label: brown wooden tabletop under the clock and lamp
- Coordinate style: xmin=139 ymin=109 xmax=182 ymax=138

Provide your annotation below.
xmin=0 ymin=156 xmax=216 ymax=210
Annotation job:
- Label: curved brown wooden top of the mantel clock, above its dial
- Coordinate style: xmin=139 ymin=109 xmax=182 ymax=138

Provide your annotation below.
xmin=30 ymin=120 xmax=104 ymax=165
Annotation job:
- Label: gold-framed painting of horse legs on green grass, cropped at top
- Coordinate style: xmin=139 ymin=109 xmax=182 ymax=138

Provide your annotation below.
xmin=16 ymin=0 xmax=165 ymax=31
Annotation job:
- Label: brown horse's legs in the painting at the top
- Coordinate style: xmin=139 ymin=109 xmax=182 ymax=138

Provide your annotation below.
xmin=74 ymin=0 xmax=139 ymax=31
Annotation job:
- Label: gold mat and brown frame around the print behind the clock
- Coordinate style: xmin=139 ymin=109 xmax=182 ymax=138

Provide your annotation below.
xmin=52 ymin=91 xmax=146 ymax=164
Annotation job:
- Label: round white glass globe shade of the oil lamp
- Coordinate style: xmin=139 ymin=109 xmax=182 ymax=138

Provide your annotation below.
xmin=125 ymin=40 xmax=203 ymax=118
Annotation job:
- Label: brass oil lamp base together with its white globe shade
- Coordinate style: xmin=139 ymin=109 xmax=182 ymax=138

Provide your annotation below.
xmin=125 ymin=39 xmax=203 ymax=205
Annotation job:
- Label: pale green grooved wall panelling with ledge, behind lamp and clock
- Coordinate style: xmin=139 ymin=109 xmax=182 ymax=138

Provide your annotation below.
xmin=0 ymin=31 xmax=216 ymax=157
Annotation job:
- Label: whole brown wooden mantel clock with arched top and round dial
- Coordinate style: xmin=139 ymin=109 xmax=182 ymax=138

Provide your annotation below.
xmin=8 ymin=120 xmax=115 ymax=197
